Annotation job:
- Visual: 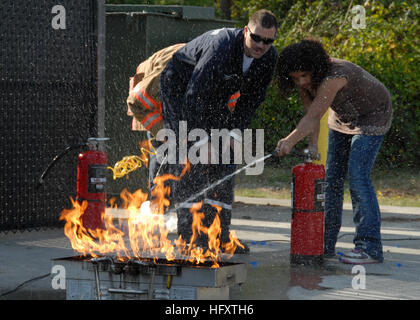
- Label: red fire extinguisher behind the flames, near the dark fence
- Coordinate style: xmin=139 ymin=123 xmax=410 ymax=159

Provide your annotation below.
xmin=76 ymin=138 xmax=108 ymax=230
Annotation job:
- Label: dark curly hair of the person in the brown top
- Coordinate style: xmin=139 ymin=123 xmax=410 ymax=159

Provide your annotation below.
xmin=275 ymin=39 xmax=331 ymax=97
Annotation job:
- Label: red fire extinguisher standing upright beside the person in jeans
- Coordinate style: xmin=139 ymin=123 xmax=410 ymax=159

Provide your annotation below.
xmin=290 ymin=150 xmax=325 ymax=265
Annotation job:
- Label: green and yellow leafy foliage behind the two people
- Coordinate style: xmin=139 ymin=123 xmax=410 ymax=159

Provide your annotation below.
xmin=107 ymin=0 xmax=420 ymax=167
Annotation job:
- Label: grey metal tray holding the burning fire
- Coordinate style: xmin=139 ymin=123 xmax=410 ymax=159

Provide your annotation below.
xmin=52 ymin=256 xmax=246 ymax=300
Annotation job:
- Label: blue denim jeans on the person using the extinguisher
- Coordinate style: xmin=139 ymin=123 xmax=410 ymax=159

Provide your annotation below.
xmin=324 ymin=130 xmax=384 ymax=262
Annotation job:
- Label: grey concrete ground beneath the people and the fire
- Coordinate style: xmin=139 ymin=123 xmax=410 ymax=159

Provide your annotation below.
xmin=0 ymin=197 xmax=420 ymax=300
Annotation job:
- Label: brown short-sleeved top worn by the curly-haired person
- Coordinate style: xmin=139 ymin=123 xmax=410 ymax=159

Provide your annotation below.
xmin=327 ymin=58 xmax=393 ymax=136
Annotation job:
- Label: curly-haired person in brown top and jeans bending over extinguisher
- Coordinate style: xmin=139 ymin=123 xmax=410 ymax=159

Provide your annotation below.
xmin=276 ymin=40 xmax=392 ymax=264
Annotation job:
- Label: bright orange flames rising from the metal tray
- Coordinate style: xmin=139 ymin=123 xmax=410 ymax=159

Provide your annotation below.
xmin=60 ymin=155 xmax=241 ymax=268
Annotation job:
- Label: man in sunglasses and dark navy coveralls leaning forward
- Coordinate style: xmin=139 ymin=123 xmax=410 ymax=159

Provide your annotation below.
xmin=155 ymin=10 xmax=277 ymax=253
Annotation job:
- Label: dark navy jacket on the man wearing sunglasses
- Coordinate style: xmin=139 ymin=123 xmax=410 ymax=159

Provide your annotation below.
xmin=160 ymin=28 xmax=277 ymax=133
